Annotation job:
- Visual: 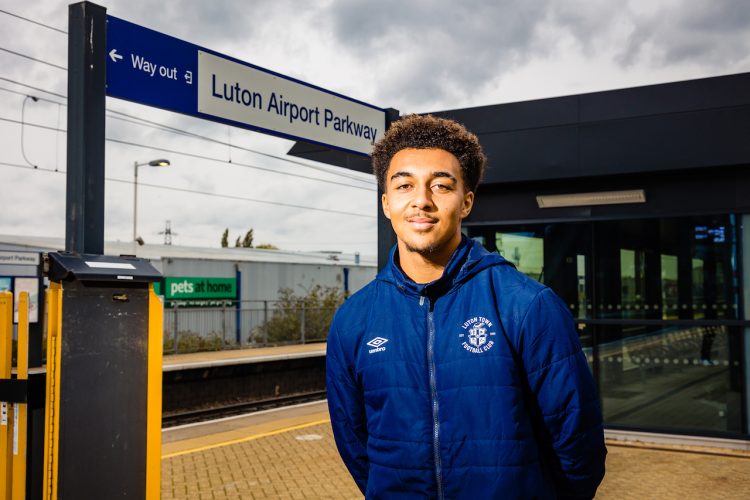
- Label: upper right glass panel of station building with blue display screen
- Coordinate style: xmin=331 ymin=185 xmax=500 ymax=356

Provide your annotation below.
xmin=593 ymin=215 xmax=740 ymax=320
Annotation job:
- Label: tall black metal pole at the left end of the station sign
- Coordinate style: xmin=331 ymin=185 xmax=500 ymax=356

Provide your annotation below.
xmin=65 ymin=2 xmax=107 ymax=254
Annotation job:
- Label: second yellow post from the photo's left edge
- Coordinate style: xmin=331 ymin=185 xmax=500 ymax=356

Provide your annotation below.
xmin=12 ymin=292 xmax=29 ymax=500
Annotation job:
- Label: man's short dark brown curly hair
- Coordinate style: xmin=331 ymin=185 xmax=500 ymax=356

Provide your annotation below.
xmin=372 ymin=115 xmax=487 ymax=192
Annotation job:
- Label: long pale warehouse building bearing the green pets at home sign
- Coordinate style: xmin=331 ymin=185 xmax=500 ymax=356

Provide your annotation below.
xmin=0 ymin=235 xmax=377 ymax=348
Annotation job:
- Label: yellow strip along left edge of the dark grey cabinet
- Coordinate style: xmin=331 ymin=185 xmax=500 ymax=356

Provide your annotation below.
xmin=42 ymin=281 xmax=62 ymax=500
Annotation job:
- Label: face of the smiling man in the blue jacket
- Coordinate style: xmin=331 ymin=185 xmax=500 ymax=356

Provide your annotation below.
xmin=383 ymin=149 xmax=474 ymax=258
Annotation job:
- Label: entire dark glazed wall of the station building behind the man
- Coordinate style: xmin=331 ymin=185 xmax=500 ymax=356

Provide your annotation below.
xmin=467 ymin=214 xmax=750 ymax=433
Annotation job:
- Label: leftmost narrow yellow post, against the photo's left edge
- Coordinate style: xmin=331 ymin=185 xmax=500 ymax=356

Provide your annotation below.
xmin=0 ymin=292 xmax=13 ymax=500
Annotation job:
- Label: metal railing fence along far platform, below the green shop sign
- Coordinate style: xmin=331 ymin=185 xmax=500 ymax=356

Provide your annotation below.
xmin=164 ymin=301 xmax=335 ymax=354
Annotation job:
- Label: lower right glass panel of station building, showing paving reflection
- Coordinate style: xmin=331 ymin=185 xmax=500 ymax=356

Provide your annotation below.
xmin=597 ymin=326 xmax=743 ymax=433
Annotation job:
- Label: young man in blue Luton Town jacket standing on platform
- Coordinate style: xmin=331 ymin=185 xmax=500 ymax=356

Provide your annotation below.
xmin=326 ymin=116 xmax=607 ymax=500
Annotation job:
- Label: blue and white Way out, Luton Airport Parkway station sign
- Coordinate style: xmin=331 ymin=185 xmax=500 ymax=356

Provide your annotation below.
xmin=107 ymin=16 xmax=385 ymax=155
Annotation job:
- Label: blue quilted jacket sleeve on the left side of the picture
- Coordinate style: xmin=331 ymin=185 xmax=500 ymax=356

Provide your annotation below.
xmin=326 ymin=320 xmax=369 ymax=493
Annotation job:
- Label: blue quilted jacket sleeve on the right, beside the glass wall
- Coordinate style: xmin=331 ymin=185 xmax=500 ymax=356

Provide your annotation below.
xmin=520 ymin=288 xmax=607 ymax=498
